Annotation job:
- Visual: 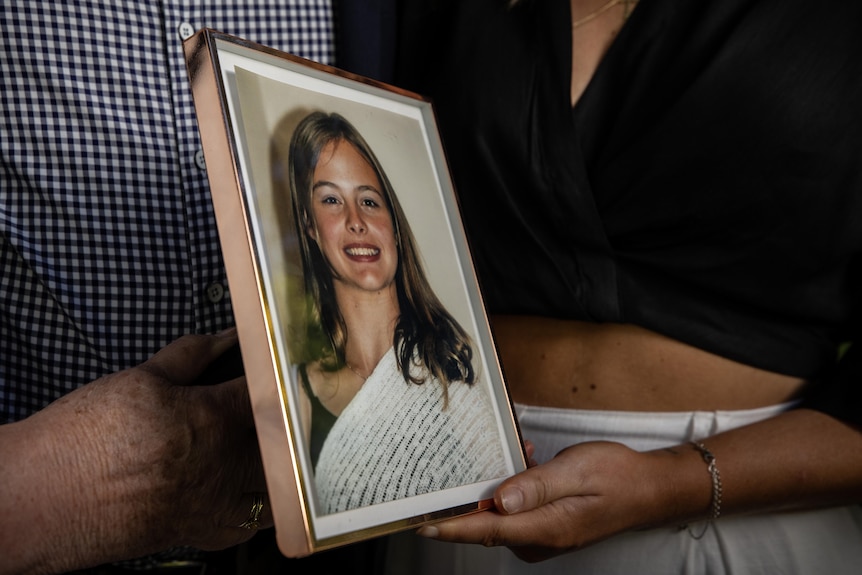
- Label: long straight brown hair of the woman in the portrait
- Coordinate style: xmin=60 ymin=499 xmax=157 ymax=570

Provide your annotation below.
xmin=288 ymin=112 xmax=476 ymax=389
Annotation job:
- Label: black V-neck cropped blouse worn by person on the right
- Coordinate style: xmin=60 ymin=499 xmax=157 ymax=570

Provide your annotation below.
xmin=402 ymin=0 xmax=862 ymax=421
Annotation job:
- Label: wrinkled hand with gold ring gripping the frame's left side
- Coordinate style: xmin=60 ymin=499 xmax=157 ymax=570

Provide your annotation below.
xmin=5 ymin=331 xmax=272 ymax=567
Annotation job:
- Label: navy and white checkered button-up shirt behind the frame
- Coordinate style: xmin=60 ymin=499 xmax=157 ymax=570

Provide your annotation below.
xmin=0 ymin=0 xmax=335 ymax=423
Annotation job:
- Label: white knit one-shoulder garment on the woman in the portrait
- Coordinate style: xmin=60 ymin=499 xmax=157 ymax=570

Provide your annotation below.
xmin=315 ymin=349 xmax=506 ymax=514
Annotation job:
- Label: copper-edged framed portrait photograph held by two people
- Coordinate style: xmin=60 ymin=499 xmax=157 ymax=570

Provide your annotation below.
xmin=185 ymin=30 xmax=526 ymax=557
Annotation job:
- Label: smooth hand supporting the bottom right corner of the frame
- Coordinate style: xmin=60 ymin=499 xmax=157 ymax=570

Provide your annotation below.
xmin=419 ymin=442 xmax=676 ymax=562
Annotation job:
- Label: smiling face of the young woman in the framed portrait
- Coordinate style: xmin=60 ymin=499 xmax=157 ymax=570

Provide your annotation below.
xmin=307 ymin=140 xmax=398 ymax=292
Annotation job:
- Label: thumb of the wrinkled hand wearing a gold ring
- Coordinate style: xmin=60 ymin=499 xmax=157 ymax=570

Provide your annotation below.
xmin=140 ymin=328 xmax=238 ymax=385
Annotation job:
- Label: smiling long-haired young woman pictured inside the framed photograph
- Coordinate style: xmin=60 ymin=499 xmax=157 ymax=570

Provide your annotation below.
xmin=288 ymin=112 xmax=506 ymax=513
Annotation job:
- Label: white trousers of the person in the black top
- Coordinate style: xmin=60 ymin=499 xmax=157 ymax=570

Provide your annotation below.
xmin=387 ymin=405 xmax=862 ymax=575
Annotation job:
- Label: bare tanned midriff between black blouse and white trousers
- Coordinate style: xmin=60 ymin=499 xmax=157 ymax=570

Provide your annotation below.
xmin=491 ymin=316 xmax=804 ymax=411
